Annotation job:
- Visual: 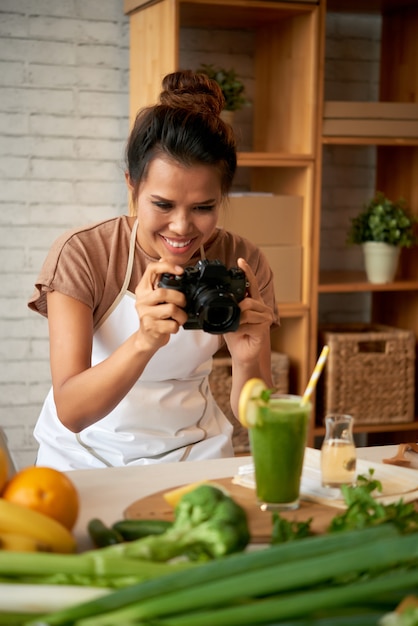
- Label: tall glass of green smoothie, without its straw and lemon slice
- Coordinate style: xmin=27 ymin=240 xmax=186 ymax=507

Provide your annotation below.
xmin=249 ymin=396 xmax=312 ymax=510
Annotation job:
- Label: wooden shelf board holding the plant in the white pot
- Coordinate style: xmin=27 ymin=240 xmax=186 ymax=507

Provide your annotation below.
xmin=318 ymin=271 xmax=418 ymax=293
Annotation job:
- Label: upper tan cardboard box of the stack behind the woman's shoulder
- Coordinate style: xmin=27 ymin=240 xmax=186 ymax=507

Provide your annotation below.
xmin=219 ymin=194 xmax=303 ymax=246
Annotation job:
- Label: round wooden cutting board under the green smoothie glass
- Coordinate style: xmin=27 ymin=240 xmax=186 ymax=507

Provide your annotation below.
xmin=124 ymin=478 xmax=342 ymax=543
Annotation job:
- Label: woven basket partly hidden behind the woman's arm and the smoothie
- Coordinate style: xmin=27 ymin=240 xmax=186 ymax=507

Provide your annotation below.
xmin=209 ymin=352 xmax=289 ymax=454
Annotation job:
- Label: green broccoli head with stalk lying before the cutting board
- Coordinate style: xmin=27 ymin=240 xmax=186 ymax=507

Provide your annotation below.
xmin=125 ymin=484 xmax=250 ymax=561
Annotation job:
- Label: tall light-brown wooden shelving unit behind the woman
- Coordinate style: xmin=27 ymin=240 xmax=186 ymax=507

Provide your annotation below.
xmin=124 ymin=0 xmax=418 ymax=444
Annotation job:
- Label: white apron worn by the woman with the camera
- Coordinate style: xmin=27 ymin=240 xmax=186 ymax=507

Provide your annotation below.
xmin=34 ymin=223 xmax=234 ymax=471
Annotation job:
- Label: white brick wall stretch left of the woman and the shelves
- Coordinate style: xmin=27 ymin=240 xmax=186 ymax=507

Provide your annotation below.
xmin=0 ymin=0 xmax=129 ymax=467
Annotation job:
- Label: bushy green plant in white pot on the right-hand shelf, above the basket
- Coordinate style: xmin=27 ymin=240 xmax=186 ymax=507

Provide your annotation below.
xmin=348 ymin=191 xmax=418 ymax=283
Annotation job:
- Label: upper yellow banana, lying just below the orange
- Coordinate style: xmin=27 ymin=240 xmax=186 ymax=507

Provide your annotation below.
xmin=0 ymin=498 xmax=76 ymax=553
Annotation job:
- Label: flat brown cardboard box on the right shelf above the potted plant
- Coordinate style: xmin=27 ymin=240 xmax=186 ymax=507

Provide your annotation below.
xmin=322 ymin=102 xmax=418 ymax=137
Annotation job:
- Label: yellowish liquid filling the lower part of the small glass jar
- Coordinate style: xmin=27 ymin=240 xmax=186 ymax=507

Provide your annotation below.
xmin=321 ymin=439 xmax=356 ymax=487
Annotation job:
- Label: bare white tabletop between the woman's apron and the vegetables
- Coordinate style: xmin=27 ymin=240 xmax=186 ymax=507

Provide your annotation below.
xmin=68 ymin=445 xmax=397 ymax=550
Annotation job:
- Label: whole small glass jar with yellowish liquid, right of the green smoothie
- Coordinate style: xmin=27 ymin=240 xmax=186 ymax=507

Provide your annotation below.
xmin=321 ymin=413 xmax=357 ymax=488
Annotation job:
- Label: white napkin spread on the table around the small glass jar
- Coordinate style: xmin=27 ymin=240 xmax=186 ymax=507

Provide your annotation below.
xmin=233 ymin=448 xmax=418 ymax=508
